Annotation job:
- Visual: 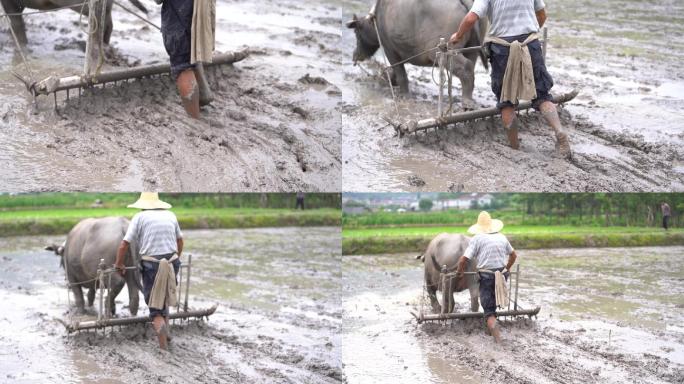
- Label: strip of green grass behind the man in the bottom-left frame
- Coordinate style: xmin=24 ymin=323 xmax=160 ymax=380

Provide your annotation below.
xmin=0 ymin=208 xmax=341 ymax=236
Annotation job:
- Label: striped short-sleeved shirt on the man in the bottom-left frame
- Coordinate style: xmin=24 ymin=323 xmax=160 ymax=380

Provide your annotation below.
xmin=124 ymin=209 xmax=183 ymax=256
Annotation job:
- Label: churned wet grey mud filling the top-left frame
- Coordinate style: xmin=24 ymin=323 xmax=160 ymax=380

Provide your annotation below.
xmin=0 ymin=0 xmax=342 ymax=192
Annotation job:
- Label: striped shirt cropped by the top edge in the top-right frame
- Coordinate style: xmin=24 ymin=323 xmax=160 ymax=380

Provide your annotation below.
xmin=470 ymin=0 xmax=546 ymax=37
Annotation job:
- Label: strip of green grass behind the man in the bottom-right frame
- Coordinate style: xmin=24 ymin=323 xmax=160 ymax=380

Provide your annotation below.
xmin=342 ymin=226 xmax=684 ymax=255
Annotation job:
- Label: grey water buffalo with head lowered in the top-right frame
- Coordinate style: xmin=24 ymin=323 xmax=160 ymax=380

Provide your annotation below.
xmin=347 ymin=0 xmax=488 ymax=108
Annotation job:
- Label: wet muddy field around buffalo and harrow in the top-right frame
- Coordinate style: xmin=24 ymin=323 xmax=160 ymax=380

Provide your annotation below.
xmin=341 ymin=0 xmax=684 ymax=191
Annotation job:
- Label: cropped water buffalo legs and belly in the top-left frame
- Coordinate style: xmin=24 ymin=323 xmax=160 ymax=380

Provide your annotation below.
xmin=0 ymin=0 xmax=147 ymax=46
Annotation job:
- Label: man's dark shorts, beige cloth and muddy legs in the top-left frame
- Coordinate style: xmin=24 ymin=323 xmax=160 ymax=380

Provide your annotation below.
xmin=155 ymin=0 xmax=216 ymax=119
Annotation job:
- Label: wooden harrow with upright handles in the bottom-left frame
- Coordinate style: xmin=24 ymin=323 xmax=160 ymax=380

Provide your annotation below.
xmin=60 ymin=255 xmax=218 ymax=333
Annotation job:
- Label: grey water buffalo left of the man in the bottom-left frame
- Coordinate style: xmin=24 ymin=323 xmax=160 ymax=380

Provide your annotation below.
xmin=45 ymin=217 xmax=140 ymax=316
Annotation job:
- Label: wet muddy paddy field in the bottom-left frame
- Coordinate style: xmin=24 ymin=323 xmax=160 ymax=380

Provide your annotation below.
xmin=0 ymin=228 xmax=343 ymax=383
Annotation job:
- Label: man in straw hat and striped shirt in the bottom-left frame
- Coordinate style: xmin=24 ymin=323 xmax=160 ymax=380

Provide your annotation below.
xmin=114 ymin=192 xmax=183 ymax=349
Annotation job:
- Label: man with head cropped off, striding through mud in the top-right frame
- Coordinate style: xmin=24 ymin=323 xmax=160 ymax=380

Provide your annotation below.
xmin=450 ymin=0 xmax=572 ymax=159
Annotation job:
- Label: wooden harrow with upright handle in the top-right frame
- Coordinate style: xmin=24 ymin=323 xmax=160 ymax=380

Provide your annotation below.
xmin=386 ymin=27 xmax=579 ymax=136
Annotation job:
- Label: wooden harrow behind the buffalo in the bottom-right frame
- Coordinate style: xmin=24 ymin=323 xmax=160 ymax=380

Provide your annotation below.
xmin=411 ymin=264 xmax=541 ymax=324
